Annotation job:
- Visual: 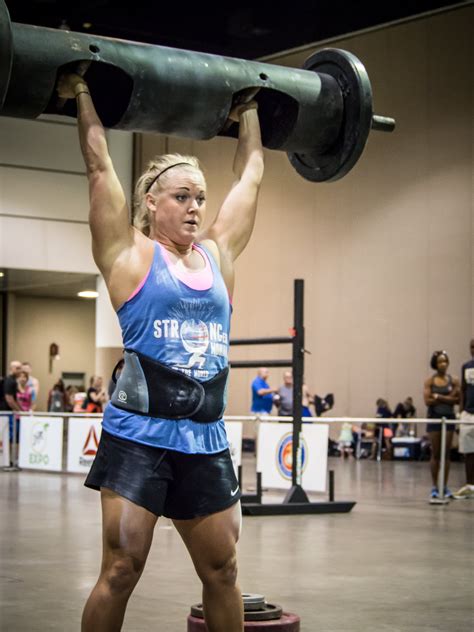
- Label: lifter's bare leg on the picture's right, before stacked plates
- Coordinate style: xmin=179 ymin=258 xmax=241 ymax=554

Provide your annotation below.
xmin=173 ymin=503 xmax=244 ymax=632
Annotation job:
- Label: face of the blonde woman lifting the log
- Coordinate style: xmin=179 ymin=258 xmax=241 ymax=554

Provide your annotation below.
xmin=147 ymin=167 xmax=206 ymax=246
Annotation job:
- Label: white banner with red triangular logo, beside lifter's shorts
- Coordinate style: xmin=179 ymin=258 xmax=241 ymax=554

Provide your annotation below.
xmin=67 ymin=417 xmax=102 ymax=474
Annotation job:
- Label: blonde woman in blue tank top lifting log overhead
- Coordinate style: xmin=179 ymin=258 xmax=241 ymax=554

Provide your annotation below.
xmin=57 ymin=74 xmax=263 ymax=632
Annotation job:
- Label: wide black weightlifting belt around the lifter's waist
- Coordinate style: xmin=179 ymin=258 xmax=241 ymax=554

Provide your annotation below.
xmin=110 ymin=349 xmax=229 ymax=423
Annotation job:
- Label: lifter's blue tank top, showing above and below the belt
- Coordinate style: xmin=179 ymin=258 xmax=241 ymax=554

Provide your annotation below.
xmin=102 ymin=243 xmax=231 ymax=454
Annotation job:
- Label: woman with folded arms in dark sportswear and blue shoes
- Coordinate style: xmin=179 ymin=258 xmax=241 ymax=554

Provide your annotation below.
xmin=423 ymin=351 xmax=459 ymax=499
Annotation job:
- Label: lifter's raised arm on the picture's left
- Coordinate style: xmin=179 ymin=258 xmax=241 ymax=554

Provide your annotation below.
xmin=57 ymin=74 xmax=133 ymax=281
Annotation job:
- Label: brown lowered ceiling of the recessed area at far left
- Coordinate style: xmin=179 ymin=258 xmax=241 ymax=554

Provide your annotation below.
xmin=0 ymin=268 xmax=97 ymax=300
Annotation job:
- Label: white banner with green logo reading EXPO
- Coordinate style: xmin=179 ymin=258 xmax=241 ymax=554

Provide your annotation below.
xmin=19 ymin=417 xmax=64 ymax=472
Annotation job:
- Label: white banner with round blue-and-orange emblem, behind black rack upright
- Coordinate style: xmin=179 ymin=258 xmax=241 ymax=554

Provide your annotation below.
xmin=257 ymin=422 xmax=329 ymax=492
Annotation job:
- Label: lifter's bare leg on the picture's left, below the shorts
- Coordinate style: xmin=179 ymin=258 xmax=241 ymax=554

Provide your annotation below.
xmin=82 ymin=488 xmax=157 ymax=632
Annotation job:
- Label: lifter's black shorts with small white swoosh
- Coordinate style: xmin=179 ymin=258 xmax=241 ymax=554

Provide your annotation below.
xmin=84 ymin=431 xmax=241 ymax=520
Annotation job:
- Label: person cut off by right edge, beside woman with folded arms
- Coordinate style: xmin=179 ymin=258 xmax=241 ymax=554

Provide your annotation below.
xmin=453 ymin=338 xmax=474 ymax=500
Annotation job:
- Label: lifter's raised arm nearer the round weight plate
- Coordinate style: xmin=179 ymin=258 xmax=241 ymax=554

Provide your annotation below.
xmin=202 ymin=101 xmax=263 ymax=286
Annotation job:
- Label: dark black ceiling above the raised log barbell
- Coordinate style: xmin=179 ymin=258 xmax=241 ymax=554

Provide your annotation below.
xmin=6 ymin=0 xmax=466 ymax=59
